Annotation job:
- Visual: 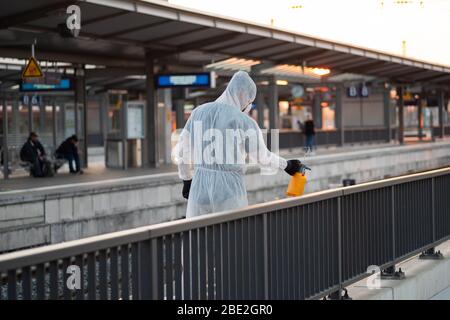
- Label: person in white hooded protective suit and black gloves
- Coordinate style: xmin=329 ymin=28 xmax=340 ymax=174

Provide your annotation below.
xmin=174 ymin=71 xmax=300 ymax=218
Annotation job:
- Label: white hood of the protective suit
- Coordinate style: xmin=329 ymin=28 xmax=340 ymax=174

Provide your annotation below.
xmin=216 ymin=71 xmax=256 ymax=112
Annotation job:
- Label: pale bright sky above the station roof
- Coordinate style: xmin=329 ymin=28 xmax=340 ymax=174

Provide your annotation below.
xmin=169 ymin=0 xmax=450 ymax=66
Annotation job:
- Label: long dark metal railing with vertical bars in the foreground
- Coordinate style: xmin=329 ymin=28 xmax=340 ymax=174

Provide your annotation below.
xmin=0 ymin=168 xmax=450 ymax=300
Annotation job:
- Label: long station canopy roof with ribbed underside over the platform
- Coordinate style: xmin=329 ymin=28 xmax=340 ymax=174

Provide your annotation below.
xmin=0 ymin=0 xmax=450 ymax=90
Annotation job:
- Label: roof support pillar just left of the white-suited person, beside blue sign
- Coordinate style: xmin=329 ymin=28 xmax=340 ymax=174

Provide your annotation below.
xmin=142 ymin=51 xmax=159 ymax=168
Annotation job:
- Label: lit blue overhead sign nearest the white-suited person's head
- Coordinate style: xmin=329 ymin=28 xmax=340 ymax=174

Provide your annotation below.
xmin=155 ymin=72 xmax=215 ymax=88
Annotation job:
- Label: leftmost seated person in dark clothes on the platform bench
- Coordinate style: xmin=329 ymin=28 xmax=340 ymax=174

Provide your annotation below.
xmin=20 ymin=132 xmax=52 ymax=177
